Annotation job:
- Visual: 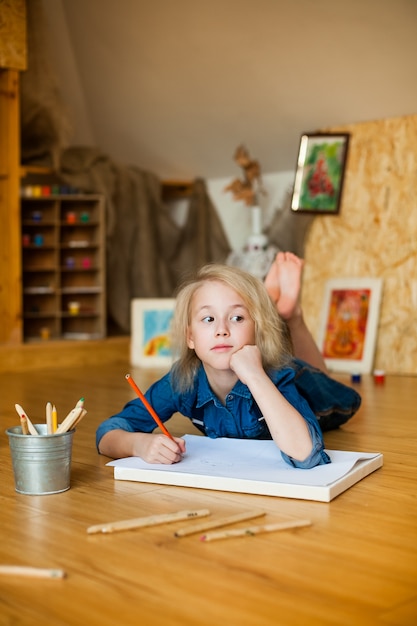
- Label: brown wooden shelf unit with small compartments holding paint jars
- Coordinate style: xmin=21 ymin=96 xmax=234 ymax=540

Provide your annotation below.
xmin=21 ymin=194 xmax=107 ymax=342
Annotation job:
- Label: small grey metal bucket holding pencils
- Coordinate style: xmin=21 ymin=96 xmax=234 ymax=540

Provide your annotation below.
xmin=6 ymin=424 xmax=75 ymax=496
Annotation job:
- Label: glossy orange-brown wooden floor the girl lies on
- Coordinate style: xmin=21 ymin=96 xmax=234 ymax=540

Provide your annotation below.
xmin=0 ymin=346 xmax=417 ymax=626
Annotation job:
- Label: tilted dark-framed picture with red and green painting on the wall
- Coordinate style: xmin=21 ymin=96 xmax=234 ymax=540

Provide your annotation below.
xmin=291 ymin=133 xmax=350 ymax=215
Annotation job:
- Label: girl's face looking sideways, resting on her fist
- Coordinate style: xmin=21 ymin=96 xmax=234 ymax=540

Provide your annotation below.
xmin=187 ymin=281 xmax=255 ymax=370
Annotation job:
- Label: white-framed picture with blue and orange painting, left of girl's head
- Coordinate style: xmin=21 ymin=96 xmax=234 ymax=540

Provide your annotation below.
xmin=130 ymin=298 xmax=175 ymax=368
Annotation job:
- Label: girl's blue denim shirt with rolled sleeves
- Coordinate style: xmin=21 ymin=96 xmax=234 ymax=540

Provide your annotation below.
xmin=96 ymin=358 xmax=338 ymax=469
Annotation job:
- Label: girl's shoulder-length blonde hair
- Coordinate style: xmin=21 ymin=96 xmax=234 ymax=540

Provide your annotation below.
xmin=171 ymin=264 xmax=292 ymax=392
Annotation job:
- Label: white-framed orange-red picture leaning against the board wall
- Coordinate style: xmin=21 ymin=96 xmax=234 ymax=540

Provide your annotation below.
xmin=318 ymin=278 xmax=382 ymax=374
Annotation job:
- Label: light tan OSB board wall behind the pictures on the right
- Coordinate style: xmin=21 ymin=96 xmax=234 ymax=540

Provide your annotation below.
xmin=302 ymin=115 xmax=417 ymax=374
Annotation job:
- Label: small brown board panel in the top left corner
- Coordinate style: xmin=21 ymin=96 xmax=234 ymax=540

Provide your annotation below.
xmin=0 ymin=0 xmax=27 ymax=70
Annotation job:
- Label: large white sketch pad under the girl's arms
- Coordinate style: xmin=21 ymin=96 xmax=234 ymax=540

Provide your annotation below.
xmin=107 ymin=435 xmax=383 ymax=502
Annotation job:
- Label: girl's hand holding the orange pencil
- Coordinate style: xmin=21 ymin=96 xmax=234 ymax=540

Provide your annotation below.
xmin=131 ymin=433 xmax=185 ymax=465
